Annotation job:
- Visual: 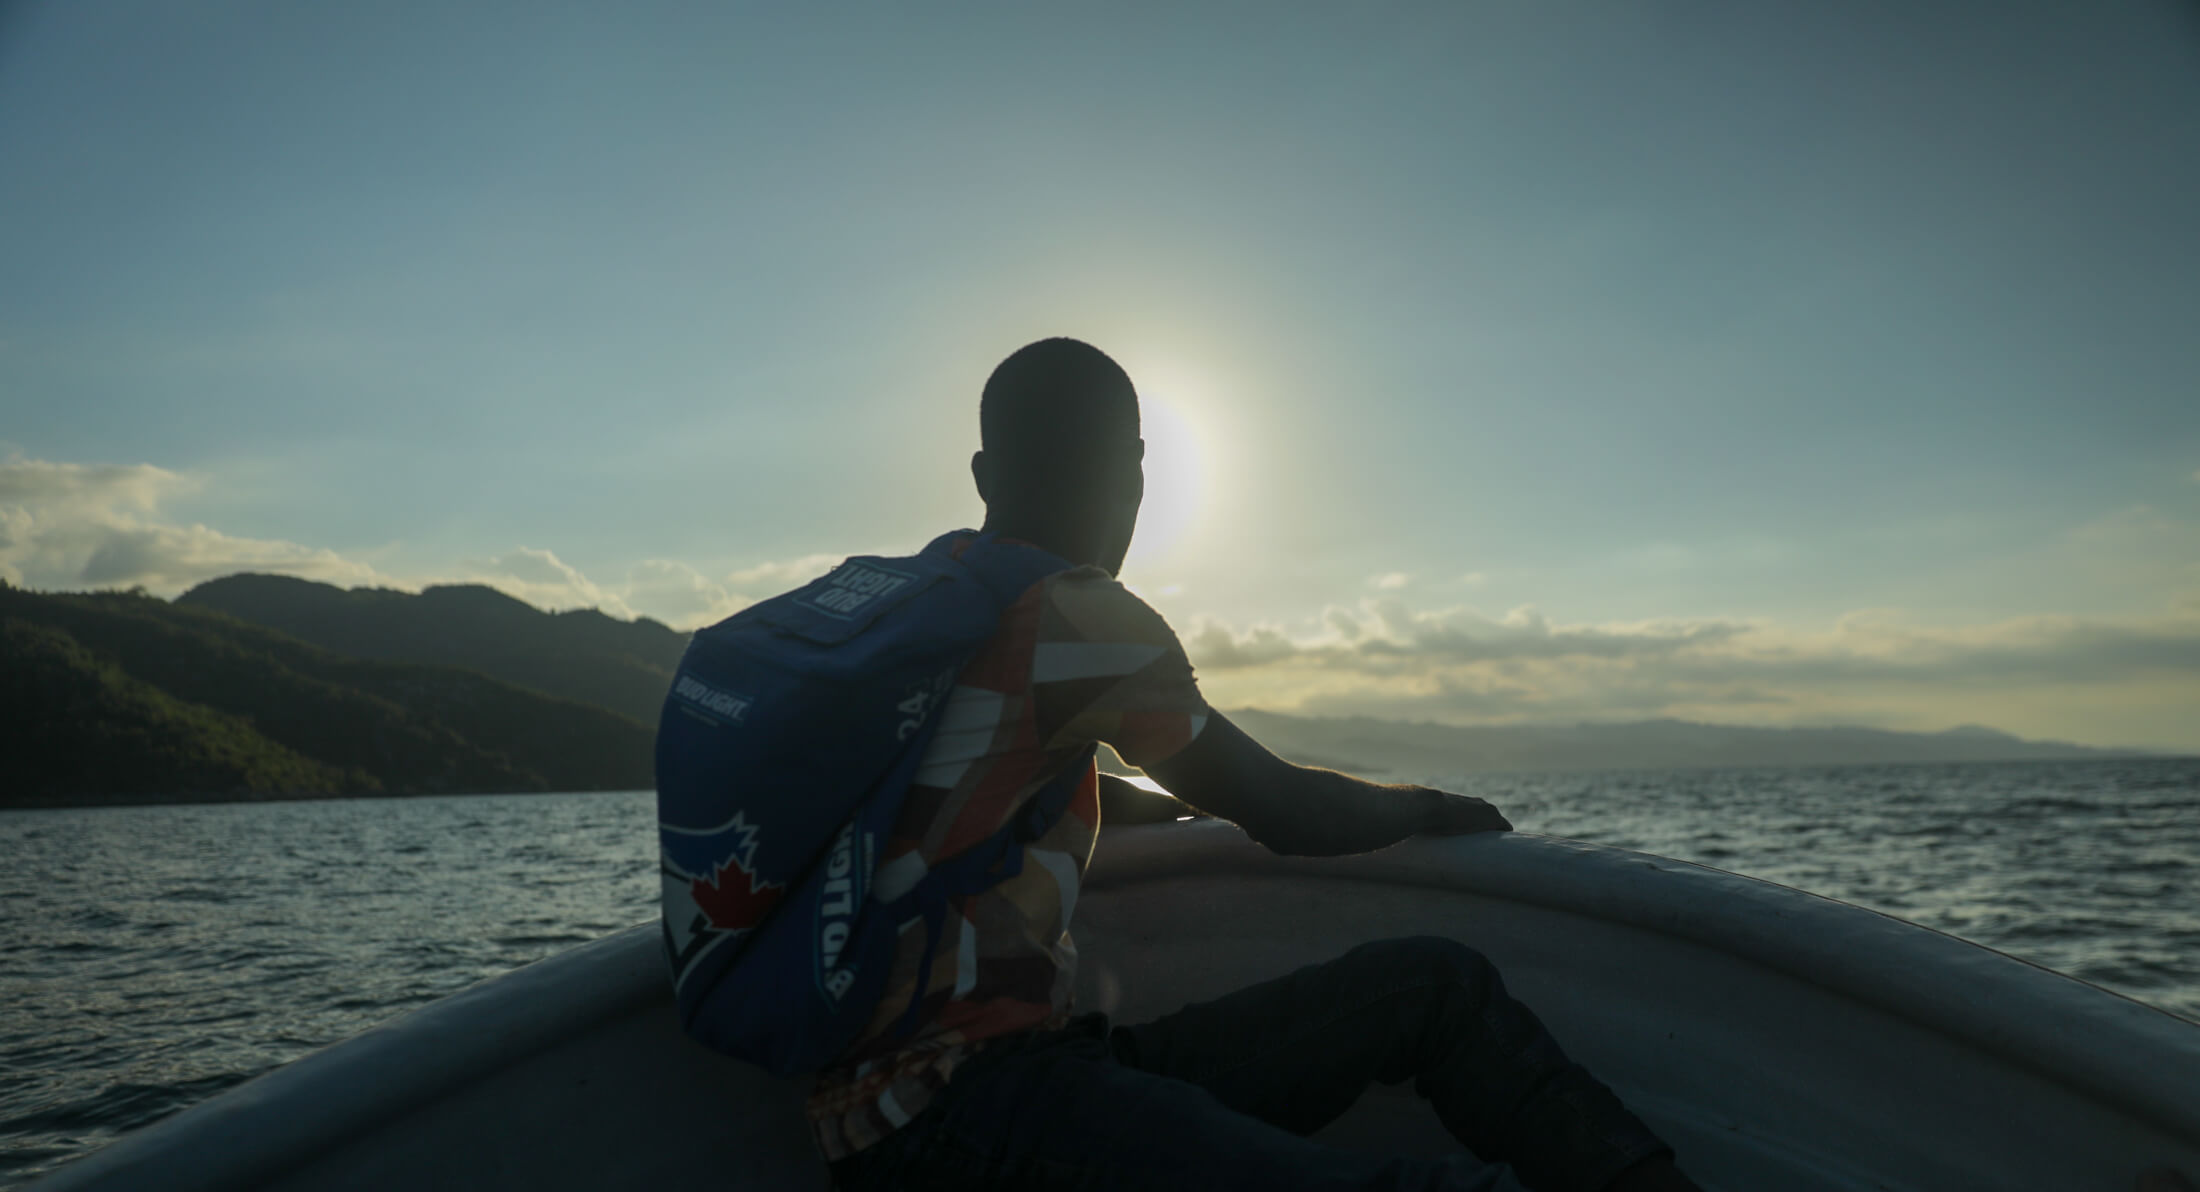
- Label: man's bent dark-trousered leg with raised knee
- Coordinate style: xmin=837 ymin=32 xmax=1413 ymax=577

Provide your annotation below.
xmin=1113 ymin=937 xmax=1670 ymax=1192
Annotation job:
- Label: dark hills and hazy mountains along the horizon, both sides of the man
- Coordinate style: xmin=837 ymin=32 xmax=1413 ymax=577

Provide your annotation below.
xmin=0 ymin=574 xmax=2156 ymax=807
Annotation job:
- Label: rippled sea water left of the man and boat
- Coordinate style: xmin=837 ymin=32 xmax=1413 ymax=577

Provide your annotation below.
xmin=0 ymin=792 xmax=656 ymax=1188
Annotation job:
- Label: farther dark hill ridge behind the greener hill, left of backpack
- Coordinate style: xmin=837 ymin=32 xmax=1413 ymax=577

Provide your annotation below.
xmin=176 ymin=574 xmax=686 ymax=724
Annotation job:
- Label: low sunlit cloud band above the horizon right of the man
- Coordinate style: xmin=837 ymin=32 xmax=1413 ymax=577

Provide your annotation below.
xmin=1184 ymin=598 xmax=2200 ymax=748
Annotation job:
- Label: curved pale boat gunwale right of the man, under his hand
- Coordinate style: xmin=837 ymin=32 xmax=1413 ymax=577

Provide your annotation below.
xmin=1085 ymin=820 xmax=2200 ymax=1146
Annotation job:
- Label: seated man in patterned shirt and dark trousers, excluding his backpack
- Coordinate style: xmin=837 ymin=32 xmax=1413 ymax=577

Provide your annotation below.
xmin=810 ymin=339 xmax=1694 ymax=1192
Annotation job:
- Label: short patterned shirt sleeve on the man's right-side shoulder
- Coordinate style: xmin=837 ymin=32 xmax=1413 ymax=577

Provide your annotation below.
xmin=1032 ymin=567 xmax=1208 ymax=768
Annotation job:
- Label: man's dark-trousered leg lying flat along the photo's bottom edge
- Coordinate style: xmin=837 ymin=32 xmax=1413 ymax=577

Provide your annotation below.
xmin=834 ymin=1027 xmax=1500 ymax=1192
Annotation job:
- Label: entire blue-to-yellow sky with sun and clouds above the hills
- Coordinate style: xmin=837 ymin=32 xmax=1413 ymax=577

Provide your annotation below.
xmin=0 ymin=0 xmax=2200 ymax=750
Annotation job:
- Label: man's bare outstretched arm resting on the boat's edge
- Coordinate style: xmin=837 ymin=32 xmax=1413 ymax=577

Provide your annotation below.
xmin=1146 ymin=713 xmax=1511 ymax=858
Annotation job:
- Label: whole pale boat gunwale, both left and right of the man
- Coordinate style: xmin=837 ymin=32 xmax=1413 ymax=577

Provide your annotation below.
xmin=29 ymin=820 xmax=2200 ymax=1192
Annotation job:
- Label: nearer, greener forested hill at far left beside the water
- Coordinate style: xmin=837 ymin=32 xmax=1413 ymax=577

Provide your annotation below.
xmin=0 ymin=585 xmax=651 ymax=807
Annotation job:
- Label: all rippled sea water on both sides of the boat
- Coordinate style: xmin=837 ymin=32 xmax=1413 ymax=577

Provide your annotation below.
xmin=0 ymin=759 xmax=2200 ymax=1188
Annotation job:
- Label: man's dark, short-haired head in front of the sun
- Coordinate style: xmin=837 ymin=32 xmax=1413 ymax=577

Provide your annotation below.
xmin=970 ymin=339 xmax=1146 ymax=574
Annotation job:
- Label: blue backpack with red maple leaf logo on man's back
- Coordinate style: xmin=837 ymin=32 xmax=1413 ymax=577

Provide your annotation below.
xmin=658 ymin=534 xmax=1085 ymax=1075
